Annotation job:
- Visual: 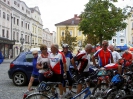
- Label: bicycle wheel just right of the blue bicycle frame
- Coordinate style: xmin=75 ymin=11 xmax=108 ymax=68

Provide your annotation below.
xmin=92 ymin=83 xmax=107 ymax=99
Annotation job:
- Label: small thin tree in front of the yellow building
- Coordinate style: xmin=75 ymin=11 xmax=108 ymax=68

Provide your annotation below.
xmin=61 ymin=26 xmax=77 ymax=51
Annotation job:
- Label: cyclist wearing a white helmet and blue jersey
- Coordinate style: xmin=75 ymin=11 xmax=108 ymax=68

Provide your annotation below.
xmin=62 ymin=44 xmax=73 ymax=98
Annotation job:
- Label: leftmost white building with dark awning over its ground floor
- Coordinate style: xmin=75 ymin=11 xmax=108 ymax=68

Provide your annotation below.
xmin=0 ymin=0 xmax=15 ymax=58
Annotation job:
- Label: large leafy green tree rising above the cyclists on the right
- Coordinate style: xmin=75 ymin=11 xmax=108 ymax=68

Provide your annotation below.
xmin=79 ymin=0 xmax=130 ymax=45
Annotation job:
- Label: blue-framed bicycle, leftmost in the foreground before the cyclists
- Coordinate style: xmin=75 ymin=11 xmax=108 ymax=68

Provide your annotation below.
xmin=24 ymin=73 xmax=97 ymax=99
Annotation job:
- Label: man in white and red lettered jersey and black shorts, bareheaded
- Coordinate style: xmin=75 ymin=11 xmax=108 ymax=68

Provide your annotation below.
xmin=49 ymin=44 xmax=66 ymax=99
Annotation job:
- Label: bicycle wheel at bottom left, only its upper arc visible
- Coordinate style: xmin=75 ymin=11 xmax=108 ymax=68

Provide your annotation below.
xmin=25 ymin=93 xmax=50 ymax=99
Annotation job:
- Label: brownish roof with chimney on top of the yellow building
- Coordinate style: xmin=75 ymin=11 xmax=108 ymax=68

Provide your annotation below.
xmin=55 ymin=14 xmax=80 ymax=26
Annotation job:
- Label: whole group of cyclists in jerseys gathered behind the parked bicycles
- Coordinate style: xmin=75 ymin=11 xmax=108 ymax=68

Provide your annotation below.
xmin=28 ymin=40 xmax=132 ymax=99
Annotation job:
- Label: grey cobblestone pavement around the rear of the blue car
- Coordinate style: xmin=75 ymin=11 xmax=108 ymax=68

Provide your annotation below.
xmin=0 ymin=61 xmax=27 ymax=99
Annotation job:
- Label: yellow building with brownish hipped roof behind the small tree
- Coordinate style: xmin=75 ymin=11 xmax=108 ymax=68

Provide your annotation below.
xmin=55 ymin=14 xmax=85 ymax=54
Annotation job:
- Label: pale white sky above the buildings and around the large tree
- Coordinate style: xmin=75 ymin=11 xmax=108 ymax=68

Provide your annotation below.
xmin=21 ymin=0 xmax=133 ymax=32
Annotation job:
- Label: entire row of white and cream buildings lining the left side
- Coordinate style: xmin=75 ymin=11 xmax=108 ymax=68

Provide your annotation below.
xmin=0 ymin=0 xmax=55 ymax=58
